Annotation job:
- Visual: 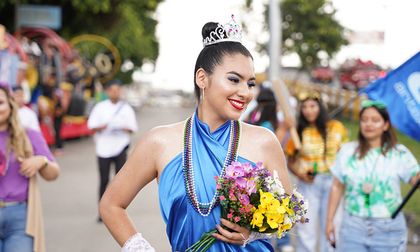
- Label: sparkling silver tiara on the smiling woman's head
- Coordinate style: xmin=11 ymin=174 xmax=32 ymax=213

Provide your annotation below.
xmin=203 ymin=15 xmax=242 ymax=47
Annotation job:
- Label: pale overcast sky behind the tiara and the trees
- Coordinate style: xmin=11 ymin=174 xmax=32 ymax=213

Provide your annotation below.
xmin=143 ymin=0 xmax=420 ymax=91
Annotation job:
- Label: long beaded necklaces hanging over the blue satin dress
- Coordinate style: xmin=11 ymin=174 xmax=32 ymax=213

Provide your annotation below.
xmin=182 ymin=114 xmax=240 ymax=217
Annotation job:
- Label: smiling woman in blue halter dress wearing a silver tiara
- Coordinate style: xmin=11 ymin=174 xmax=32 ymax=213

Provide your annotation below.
xmin=100 ymin=16 xmax=291 ymax=251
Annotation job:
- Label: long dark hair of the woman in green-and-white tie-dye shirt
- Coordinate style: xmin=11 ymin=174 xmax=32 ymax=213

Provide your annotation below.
xmin=355 ymin=106 xmax=397 ymax=159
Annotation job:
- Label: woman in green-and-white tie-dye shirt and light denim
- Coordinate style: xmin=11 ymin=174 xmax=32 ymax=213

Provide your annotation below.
xmin=326 ymin=101 xmax=420 ymax=252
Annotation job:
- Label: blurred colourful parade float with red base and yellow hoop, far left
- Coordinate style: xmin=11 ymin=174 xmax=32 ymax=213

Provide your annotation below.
xmin=0 ymin=27 xmax=121 ymax=145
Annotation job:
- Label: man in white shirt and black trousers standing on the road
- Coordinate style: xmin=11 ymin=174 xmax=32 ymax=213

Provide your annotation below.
xmin=88 ymin=80 xmax=137 ymax=222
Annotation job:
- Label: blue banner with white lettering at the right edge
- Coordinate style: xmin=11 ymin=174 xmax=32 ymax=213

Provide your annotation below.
xmin=359 ymin=52 xmax=420 ymax=141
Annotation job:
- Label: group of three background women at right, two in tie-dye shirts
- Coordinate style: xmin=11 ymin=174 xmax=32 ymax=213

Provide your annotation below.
xmin=244 ymin=85 xmax=420 ymax=251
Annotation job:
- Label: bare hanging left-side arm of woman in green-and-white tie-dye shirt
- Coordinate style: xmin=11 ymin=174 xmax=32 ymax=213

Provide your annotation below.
xmin=325 ymin=177 xmax=345 ymax=246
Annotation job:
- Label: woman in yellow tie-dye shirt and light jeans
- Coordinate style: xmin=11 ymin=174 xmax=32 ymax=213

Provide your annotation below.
xmin=285 ymin=91 xmax=347 ymax=252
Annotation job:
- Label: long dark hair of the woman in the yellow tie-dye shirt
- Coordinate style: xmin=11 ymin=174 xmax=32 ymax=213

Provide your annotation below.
xmin=297 ymin=98 xmax=329 ymax=154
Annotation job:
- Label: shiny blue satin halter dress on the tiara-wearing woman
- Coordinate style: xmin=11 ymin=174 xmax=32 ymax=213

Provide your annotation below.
xmin=159 ymin=116 xmax=274 ymax=252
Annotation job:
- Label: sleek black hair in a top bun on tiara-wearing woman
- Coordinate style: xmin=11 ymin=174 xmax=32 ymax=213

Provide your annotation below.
xmin=194 ymin=22 xmax=253 ymax=100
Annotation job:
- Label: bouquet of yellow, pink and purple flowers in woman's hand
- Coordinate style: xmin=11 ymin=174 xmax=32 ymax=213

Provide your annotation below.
xmin=186 ymin=162 xmax=308 ymax=252
